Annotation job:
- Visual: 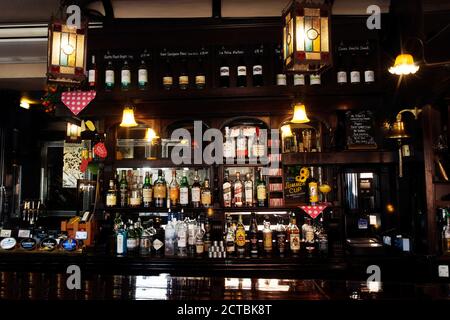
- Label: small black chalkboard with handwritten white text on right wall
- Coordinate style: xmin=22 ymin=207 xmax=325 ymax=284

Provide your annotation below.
xmin=345 ymin=110 xmax=377 ymax=149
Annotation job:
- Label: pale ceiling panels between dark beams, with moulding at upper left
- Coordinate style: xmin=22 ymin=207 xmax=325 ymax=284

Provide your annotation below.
xmin=0 ymin=0 xmax=450 ymax=90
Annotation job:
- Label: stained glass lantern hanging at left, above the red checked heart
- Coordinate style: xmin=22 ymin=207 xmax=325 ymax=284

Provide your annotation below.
xmin=47 ymin=22 xmax=87 ymax=84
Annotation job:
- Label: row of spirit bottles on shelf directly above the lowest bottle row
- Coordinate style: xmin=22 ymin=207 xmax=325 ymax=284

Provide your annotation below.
xmin=106 ymin=169 xmax=267 ymax=208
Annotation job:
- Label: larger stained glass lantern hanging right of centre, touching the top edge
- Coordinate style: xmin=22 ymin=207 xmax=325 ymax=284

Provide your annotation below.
xmin=283 ymin=0 xmax=332 ymax=73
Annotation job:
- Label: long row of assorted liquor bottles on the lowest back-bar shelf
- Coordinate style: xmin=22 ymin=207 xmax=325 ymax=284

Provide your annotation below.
xmin=114 ymin=210 xmax=328 ymax=258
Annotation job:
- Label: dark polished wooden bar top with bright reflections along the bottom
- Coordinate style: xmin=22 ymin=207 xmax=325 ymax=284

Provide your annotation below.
xmin=0 ymin=272 xmax=450 ymax=301
